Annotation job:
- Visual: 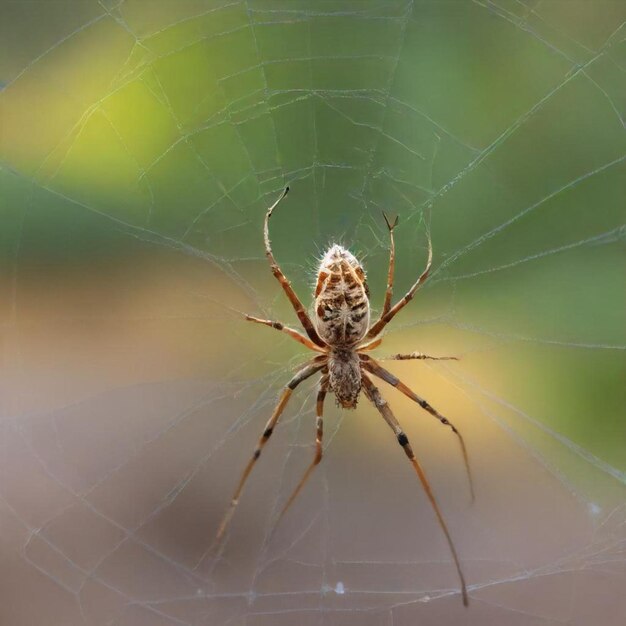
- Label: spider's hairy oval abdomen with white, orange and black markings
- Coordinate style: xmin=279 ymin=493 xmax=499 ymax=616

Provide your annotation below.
xmin=314 ymin=245 xmax=370 ymax=346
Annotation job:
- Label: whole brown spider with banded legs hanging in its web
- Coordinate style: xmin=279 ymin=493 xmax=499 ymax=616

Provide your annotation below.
xmin=217 ymin=187 xmax=474 ymax=606
